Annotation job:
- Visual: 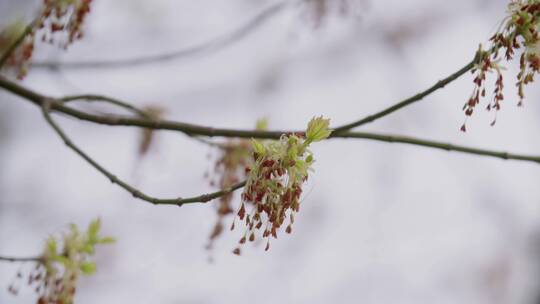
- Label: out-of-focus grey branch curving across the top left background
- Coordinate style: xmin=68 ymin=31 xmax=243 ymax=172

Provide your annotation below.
xmin=32 ymin=1 xmax=291 ymax=69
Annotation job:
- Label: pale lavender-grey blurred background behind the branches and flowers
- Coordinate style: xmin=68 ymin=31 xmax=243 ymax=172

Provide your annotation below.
xmin=0 ymin=0 xmax=540 ymax=304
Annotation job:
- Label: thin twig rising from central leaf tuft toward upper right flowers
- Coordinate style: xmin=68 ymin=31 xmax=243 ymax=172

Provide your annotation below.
xmin=334 ymin=56 xmax=478 ymax=134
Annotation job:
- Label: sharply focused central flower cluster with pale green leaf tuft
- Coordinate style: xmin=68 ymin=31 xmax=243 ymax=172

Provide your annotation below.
xmin=231 ymin=117 xmax=331 ymax=255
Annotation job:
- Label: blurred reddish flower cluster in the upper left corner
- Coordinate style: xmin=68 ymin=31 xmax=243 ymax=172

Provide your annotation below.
xmin=0 ymin=0 xmax=92 ymax=79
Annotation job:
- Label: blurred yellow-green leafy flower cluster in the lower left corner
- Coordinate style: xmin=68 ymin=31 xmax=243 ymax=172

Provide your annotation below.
xmin=8 ymin=219 xmax=114 ymax=304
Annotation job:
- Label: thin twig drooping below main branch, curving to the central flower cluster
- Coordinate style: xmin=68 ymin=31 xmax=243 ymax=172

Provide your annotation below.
xmin=42 ymin=102 xmax=245 ymax=206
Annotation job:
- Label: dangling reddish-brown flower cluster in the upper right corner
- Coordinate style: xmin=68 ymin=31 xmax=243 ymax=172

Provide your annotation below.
xmin=461 ymin=0 xmax=540 ymax=132
